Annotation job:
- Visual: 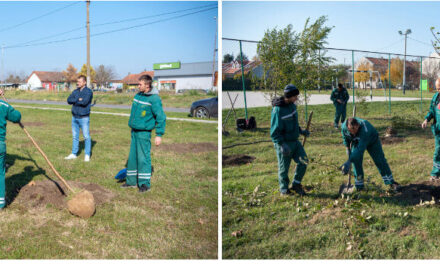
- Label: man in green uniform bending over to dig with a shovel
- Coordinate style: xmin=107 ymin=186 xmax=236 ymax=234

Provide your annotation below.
xmin=341 ymin=117 xmax=399 ymax=191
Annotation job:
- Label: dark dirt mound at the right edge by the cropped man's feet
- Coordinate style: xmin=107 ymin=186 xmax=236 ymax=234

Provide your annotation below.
xmin=394 ymin=181 xmax=440 ymax=205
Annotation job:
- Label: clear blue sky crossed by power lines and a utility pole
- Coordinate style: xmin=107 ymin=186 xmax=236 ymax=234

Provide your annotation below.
xmin=0 ymin=1 xmax=218 ymax=78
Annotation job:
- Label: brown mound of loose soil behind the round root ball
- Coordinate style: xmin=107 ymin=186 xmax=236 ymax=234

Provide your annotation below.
xmin=12 ymin=180 xmax=115 ymax=209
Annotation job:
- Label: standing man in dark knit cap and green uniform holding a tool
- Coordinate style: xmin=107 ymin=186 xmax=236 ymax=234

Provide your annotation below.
xmin=270 ymin=84 xmax=310 ymax=195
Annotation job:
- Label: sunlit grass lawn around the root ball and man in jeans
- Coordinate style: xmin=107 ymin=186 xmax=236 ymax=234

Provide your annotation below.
xmin=0 ymin=105 xmax=218 ymax=259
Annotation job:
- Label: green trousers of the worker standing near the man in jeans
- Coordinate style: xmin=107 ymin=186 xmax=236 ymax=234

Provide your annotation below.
xmin=126 ymin=130 xmax=151 ymax=187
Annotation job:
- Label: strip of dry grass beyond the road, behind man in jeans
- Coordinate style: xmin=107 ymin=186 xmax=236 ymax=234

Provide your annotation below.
xmin=5 ymin=90 xmax=216 ymax=108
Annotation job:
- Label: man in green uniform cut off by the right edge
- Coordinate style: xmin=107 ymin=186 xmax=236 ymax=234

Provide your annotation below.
xmin=422 ymin=78 xmax=440 ymax=181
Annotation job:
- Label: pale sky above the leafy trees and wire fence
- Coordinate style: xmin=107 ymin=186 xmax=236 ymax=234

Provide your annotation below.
xmin=222 ymin=1 xmax=440 ymax=63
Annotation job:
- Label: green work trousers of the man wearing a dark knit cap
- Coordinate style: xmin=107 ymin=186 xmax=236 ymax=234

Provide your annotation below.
xmin=274 ymin=140 xmax=309 ymax=192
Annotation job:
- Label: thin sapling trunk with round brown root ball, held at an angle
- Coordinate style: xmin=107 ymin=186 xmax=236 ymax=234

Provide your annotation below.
xmin=2 ymin=95 xmax=96 ymax=218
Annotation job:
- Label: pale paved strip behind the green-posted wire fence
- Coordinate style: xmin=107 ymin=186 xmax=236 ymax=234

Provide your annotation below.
xmin=222 ymin=92 xmax=424 ymax=109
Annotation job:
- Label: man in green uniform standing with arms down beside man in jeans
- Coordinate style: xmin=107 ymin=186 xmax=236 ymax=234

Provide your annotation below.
xmin=121 ymin=74 xmax=166 ymax=192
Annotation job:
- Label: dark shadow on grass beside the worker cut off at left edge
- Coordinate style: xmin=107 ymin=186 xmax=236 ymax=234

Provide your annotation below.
xmin=5 ymin=153 xmax=65 ymax=206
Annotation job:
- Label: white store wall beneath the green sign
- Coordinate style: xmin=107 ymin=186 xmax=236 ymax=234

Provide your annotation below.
xmin=157 ymin=75 xmax=212 ymax=92
